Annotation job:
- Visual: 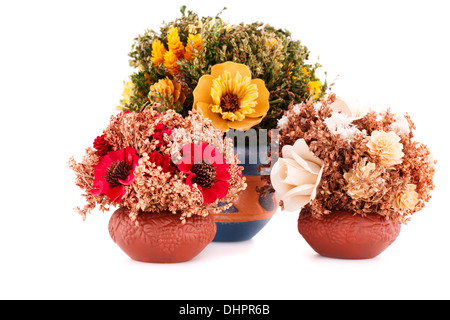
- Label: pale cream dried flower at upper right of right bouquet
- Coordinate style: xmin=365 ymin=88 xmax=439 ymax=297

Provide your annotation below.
xmin=367 ymin=130 xmax=405 ymax=169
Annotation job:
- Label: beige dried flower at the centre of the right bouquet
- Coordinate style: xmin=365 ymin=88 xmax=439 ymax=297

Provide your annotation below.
xmin=344 ymin=159 xmax=385 ymax=199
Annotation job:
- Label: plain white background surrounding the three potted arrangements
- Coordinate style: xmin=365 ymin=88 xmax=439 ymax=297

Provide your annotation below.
xmin=0 ymin=0 xmax=450 ymax=299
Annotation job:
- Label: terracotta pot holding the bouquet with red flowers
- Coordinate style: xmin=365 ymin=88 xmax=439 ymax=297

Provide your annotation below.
xmin=109 ymin=208 xmax=216 ymax=263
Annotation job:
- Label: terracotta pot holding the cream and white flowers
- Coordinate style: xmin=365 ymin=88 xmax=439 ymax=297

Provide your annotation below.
xmin=298 ymin=209 xmax=400 ymax=259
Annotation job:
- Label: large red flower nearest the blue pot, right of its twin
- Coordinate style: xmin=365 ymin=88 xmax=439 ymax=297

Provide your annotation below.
xmin=178 ymin=143 xmax=230 ymax=203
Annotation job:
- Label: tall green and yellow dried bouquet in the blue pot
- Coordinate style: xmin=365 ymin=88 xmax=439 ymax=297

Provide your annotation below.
xmin=118 ymin=7 xmax=327 ymax=131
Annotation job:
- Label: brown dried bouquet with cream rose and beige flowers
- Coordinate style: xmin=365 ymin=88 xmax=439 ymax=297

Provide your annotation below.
xmin=266 ymin=94 xmax=436 ymax=223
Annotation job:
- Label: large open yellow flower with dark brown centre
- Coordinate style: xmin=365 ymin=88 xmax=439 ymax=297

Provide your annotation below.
xmin=194 ymin=62 xmax=270 ymax=131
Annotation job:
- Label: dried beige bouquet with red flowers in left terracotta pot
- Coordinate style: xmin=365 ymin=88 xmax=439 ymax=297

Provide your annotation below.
xmin=69 ymin=105 xmax=246 ymax=222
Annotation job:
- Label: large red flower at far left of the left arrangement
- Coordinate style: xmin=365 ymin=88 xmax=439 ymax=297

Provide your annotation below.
xmin=91 ymin=147 xmax=139 ymax=202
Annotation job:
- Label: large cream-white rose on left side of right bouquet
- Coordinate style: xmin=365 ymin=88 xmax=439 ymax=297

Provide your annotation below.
xmin=270 ymin=139 xmax=323 ymax=211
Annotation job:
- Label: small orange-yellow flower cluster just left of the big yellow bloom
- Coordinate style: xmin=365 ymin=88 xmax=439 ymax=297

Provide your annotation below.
xmin=148 ymin=77 xmax=186 ymax=109
